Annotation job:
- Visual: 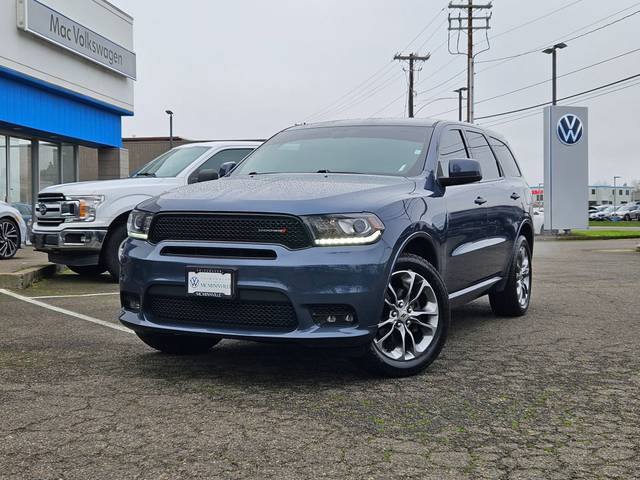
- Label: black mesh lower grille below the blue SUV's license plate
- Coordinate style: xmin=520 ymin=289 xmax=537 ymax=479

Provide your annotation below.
xmin=145 ymin=292 xmax=298 ymax=331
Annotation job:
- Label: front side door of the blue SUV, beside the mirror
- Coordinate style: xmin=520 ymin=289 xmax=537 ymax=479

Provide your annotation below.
xmin=438 ymin=127 xmax=487 ymax=292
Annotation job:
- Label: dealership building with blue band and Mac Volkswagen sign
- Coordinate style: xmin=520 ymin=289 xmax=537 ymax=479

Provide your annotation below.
xmin=0 ymin=0 xmax=136 ymax=210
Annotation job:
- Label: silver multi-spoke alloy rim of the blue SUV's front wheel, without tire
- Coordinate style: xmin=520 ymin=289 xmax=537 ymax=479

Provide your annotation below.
xmin=374 ymin=270 xmax=438 ymax=361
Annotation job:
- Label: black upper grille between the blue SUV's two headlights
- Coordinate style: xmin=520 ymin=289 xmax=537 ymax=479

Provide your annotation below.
xmin=149 ymin=213 xmax=311 ymax=249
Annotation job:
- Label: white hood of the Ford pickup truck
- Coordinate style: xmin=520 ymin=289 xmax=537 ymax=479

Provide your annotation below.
xmin=41 ymin=177 xmax=183 ymax=198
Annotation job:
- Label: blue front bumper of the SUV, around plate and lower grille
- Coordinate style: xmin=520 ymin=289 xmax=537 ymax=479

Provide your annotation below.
xmin=120 ymin=239 xmax=393 ymax=346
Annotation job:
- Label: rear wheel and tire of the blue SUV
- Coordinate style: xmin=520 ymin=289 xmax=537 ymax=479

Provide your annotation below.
xmin=489 ymin=236 xmax=532 ymax=317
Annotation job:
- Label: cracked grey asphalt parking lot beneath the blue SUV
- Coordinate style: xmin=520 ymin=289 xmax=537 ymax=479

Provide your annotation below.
xmin=0 ymin=240 xmax=640 ymax=479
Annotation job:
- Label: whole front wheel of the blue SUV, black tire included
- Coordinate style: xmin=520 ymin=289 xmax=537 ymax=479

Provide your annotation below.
xmin=355 ymin=254 xmax=450 ymax=377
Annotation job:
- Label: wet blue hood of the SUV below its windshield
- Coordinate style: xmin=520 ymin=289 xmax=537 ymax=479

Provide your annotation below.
xmin=140 ymin=173 xmax=416 ymax=215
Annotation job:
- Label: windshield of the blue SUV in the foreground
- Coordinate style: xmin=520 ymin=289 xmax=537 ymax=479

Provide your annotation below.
xmin=233 ymin=126 xmax=433 ymax=177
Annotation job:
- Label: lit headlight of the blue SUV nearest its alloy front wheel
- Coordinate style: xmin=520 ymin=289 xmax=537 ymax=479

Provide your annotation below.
xmin=303 ymin=213 xmax=384 ymax=247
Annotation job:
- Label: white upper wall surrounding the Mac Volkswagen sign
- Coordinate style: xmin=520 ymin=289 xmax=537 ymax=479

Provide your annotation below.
xmin=0 ymin=0 xmax=134 ymax=111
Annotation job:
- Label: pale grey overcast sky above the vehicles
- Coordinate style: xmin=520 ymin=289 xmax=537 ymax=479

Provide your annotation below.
xmin=111 ymin=0 xmax=640 ymax=185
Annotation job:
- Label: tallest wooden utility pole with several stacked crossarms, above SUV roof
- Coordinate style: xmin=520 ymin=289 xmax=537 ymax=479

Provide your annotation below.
xmin=448 ymin=0 xmax=493 ymax=123
